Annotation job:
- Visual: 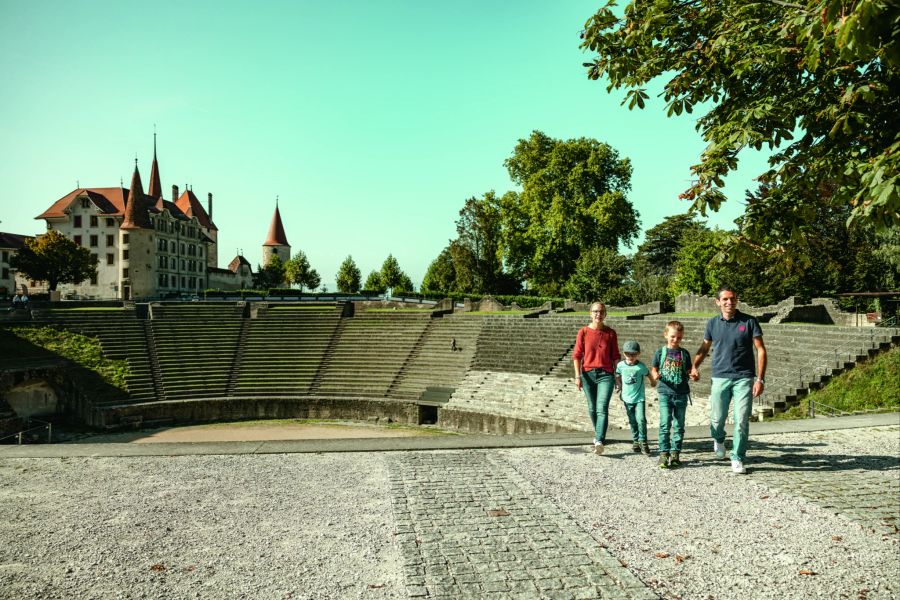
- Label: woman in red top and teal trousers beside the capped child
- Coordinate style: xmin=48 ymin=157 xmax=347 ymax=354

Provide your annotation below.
xmin=572 ymin=302 xmax=619 ymax=454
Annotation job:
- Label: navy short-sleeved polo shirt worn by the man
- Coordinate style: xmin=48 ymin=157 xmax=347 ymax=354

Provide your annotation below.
xmin=703 ymin=311 xmax=762 ymax=379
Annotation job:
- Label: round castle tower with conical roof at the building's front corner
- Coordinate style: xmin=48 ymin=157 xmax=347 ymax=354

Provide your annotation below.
xmin=119 ymin=159 xmax=156 ymax=299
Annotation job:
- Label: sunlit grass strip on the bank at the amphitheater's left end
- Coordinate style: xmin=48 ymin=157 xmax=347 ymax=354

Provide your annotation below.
xmin=11 ymin=327 xmax=129 ymax=393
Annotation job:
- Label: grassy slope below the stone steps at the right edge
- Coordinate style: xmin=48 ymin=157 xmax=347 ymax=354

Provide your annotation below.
xmin=775 ymin=348 xmax=900 ymax=419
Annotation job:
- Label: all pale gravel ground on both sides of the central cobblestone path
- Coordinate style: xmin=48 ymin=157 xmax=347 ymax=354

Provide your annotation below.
xmin=0 ymin=428 xmax=900 ymax=599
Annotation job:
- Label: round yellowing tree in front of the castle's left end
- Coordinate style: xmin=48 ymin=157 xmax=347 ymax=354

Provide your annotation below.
xmin=10 ymin=229 xmax=97 ymax=291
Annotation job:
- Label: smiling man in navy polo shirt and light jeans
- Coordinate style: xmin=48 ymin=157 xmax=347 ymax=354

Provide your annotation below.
xmin=691 ymin=286 xmax=766 ymax=474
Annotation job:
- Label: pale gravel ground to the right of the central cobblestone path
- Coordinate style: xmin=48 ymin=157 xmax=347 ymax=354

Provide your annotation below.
xmin=505 ymin=428 xmax=900 ymax=599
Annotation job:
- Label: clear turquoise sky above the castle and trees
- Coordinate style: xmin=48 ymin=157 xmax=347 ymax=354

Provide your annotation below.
xmin=0 ymin=0 xmax=765 ymax=290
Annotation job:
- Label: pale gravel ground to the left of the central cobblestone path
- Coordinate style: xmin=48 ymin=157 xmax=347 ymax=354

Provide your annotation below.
xmin=0 ymin=454 xmax=404 ymax=600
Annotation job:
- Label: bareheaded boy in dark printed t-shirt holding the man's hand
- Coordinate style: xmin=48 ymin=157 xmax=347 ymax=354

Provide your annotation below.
xmin=652 ymin=321 xmax=691 ymax=469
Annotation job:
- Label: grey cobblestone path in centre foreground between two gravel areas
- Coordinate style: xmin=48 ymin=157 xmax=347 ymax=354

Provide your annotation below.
xmin=390 ymin=451 xmax=658 ymax=600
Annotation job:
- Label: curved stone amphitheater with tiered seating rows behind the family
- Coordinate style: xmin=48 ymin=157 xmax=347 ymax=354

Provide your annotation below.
xmin=0 ymin=301 xmax=898 ymax=434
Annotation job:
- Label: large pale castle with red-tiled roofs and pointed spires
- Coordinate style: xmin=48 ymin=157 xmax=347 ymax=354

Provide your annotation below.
xmin=29 ymin=135 xmax=258 ymax=300
